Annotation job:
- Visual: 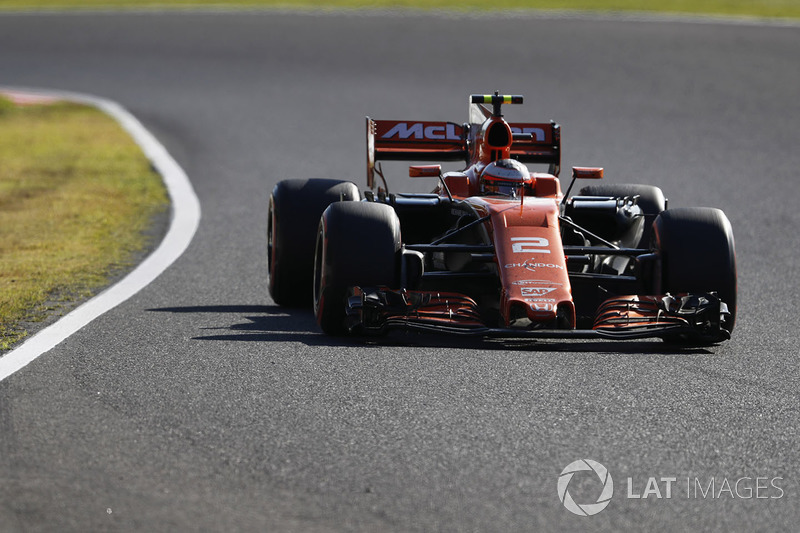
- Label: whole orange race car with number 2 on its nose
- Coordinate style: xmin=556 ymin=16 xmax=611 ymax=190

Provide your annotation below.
xmin=268 ymin=93 xmax=737 ymax=344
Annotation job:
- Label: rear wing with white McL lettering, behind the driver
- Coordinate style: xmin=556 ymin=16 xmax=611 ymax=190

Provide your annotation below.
xmin=367 ymin=117 xmax=561 ymax=189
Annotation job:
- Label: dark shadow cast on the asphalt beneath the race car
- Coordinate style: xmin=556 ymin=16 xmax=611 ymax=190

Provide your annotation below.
xmin=148 ymin=305 xmax=717 ymax=355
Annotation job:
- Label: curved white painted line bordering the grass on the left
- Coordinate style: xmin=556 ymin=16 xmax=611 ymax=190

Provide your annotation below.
xmin=0 ymin=87 xmax=200 ymax=381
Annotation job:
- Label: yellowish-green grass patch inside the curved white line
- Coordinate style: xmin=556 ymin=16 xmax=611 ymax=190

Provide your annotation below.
xmin=0 ymin=98 xmax=167 ymax=349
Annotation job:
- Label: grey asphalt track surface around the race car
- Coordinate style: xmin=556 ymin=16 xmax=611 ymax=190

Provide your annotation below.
xmin=0 ymin=12 xmax=800 ymax=531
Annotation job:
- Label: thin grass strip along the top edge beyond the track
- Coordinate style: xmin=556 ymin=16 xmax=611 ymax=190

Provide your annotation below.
xmin=0 ymin=0 xmax=800 ymax=18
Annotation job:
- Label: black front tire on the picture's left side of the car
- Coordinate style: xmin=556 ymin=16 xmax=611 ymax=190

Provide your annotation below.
xmin=313 ymin=202 xmax=401 ymax=335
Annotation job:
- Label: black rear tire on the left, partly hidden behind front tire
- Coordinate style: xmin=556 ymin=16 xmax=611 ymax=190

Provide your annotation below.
xmin=267 ymin=179 xmax=359 ymax=306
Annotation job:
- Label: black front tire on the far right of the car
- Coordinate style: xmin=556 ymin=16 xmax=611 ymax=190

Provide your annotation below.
xmin=653 ymin=207 xmax=737 ymax=332
